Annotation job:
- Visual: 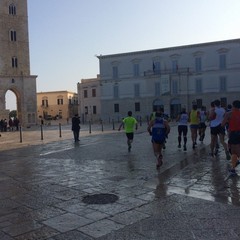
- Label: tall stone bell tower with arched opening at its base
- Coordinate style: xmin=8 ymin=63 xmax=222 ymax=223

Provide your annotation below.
xmin=0 ymin=0 xmax=37 ymax=126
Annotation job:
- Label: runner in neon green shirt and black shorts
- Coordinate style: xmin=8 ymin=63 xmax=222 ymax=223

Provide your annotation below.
xmin=118 ymin=111 xmax=138 ymax=152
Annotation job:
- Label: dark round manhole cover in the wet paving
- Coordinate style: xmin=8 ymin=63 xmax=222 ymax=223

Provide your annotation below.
xmin=82 ymin=193 xmax=118 ymax=204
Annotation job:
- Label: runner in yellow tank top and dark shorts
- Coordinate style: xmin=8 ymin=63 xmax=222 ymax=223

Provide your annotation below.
xmin=189 ymin=104 xmax=200 ymax=149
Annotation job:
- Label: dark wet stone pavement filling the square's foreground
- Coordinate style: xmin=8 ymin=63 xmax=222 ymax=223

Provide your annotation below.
xmin=0 ymin=125 xmax=240 ymax=240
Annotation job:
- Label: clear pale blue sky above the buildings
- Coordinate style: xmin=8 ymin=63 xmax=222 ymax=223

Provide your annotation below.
xmin=5 ymin=0 xmax=240 ymax=109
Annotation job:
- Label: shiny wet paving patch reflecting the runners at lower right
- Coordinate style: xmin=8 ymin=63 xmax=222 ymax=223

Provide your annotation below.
xmin=155 ymin=148 xmax=240 ymax=206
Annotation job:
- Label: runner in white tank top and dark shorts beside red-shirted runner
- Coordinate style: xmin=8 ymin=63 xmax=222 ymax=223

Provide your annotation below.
xmin=210 ymin=100 xmax=231 ymax=160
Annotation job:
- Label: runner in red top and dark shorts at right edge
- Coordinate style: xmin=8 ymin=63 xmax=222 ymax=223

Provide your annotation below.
xmin=221 ymin=100 xmax=240 ymax=175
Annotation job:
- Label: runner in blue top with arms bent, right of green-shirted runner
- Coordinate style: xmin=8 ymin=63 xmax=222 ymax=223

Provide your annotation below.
xmin=147 ymin=109 xmax=170 ymax=169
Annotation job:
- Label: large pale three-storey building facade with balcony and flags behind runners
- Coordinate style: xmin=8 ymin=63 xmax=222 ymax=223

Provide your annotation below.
xmin=98 ymin=39 xmax=240 ymax=121
